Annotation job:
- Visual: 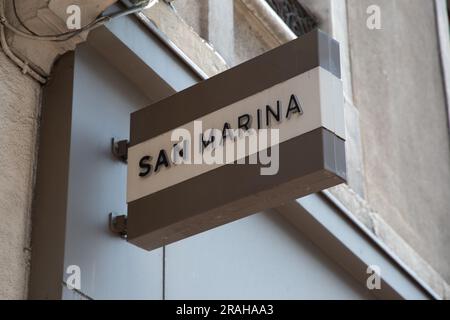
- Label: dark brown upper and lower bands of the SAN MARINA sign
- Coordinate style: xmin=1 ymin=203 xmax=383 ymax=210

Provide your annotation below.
xmin=127 ymin=30 xmax=346 ymax=250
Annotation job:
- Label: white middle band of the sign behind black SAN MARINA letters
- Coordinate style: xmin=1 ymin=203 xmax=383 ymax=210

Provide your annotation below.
xmin=127 ymin=67 xmax=345 ymax=202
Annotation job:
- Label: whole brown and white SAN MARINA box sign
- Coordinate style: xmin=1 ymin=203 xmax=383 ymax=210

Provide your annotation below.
xmin=127 ymin=31 xmax=346 ymax=250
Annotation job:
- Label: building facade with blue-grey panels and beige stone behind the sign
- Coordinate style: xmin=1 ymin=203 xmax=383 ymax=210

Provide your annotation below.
xmin=0 ymin=0 xmax=450 ymax=299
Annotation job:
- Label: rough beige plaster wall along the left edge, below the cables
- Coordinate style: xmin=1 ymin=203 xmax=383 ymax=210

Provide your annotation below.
xmin=0 ymin=49 xmax=40 ymax=299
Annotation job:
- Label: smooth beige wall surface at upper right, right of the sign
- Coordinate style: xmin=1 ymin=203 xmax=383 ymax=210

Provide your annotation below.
xmin=347 ymin=0 xmax=450 ymax=282
